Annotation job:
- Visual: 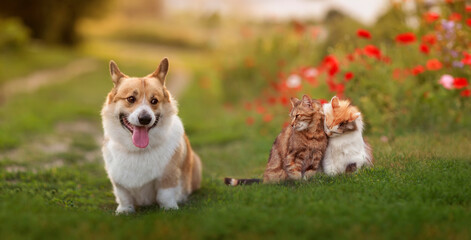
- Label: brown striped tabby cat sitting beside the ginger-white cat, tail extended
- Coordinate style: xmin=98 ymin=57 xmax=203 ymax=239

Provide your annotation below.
xmin=225 ymin=95 xmax=328 ymax=186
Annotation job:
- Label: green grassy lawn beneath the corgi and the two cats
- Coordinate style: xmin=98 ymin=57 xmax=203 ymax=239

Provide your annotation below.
xmin=0 ymin=55 xmax=471 ymax=239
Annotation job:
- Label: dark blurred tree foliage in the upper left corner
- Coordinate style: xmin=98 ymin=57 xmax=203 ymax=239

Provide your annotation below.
xmin=0 ymin=0 xmax=109 ymax=45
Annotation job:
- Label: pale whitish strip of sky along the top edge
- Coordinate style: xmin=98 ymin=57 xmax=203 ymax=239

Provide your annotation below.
xmin=164 ymin=0 xmax=390 ymax=24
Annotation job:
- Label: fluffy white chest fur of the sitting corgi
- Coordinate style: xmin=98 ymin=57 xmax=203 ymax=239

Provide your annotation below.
xmin=103 ymin=117 xmax=183 ymax=188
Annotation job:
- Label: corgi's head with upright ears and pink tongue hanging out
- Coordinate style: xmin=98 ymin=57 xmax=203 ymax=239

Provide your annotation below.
xmin=102 ymin=58 xmax=177 ymax=148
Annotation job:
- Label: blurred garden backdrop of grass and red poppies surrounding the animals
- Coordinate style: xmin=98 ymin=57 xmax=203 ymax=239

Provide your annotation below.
xmin=0 ymin=0 xmax=471 ymax=239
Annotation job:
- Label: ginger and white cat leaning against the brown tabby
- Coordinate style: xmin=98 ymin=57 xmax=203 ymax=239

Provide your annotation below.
xmin=322 ymin=96 xmax=373 ymax=175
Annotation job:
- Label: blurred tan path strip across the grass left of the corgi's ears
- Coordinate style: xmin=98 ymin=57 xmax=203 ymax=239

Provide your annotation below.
xmin=1 ymin=58 xmax=98 ymax=99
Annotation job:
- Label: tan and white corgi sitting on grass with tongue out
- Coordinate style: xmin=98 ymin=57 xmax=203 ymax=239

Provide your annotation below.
xmin=101 ymin=58 xmax=202 ymax=214
